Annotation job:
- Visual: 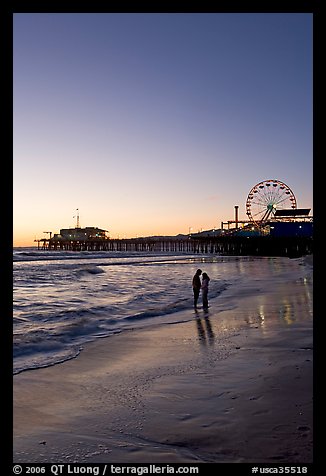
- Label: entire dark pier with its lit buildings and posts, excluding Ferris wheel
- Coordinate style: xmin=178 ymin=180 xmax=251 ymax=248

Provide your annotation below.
xmin=34 ymin=206 xmax=313 ymax=257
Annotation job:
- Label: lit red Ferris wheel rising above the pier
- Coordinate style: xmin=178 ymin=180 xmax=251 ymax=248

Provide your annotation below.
xmin=246 ymin=180 xmax=297 ymax=226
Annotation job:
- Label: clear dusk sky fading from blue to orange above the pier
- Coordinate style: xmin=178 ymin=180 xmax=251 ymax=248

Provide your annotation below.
xmin=13 ymin=13 xmax=313 ymax=246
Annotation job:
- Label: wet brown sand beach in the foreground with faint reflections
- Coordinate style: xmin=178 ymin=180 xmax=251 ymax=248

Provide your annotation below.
xmin=13 ymin=274 xmax=313 ymax=463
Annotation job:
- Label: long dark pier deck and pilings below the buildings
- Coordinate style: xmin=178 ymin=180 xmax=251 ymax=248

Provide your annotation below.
xmin=36 ymin=235 xmax=313 ymax=257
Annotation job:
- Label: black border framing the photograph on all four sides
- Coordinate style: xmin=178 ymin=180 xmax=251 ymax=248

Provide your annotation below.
xmin=6 ymin=0 xmax=324 ymax=475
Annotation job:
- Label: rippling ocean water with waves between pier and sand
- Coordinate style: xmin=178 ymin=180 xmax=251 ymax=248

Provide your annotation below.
xmin=13 ymin=248 xmax=312 ymax=374
